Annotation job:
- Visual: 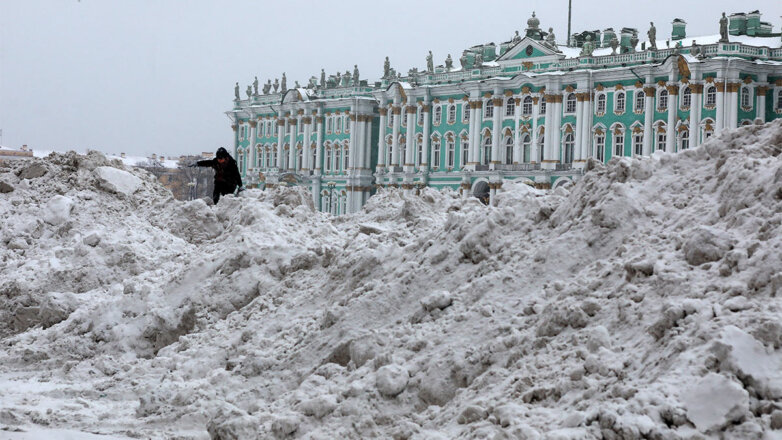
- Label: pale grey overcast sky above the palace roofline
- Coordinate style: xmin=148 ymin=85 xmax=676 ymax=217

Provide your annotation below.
xmin=0 ymin=0 xmax=782 ymax=156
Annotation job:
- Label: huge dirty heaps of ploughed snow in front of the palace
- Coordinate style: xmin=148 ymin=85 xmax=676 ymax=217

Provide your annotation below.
xmin=0 ymin=120 xmax=782 ymax=440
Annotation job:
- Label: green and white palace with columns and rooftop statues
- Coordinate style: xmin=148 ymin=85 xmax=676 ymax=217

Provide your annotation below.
xmin=227 ymin=11 xmax=782 ymax=215
